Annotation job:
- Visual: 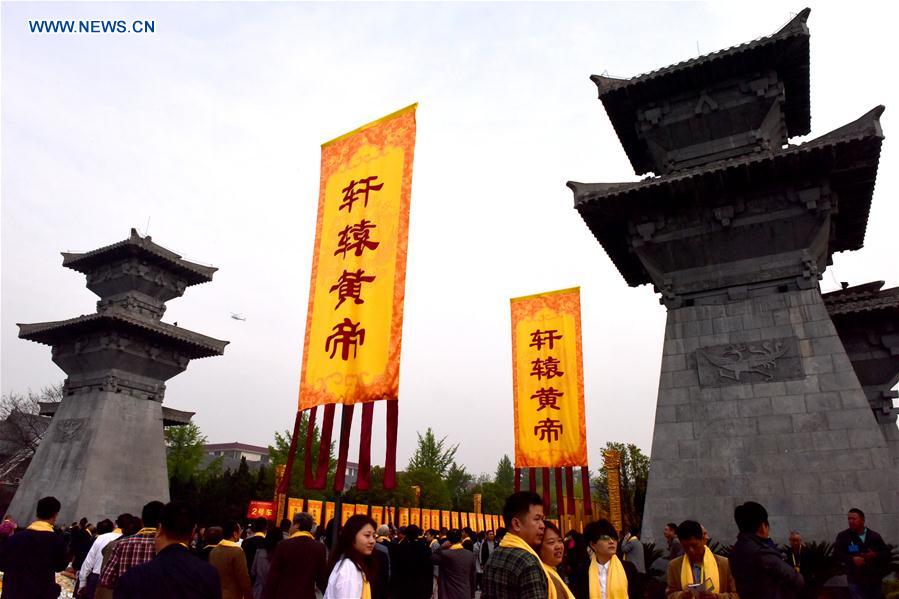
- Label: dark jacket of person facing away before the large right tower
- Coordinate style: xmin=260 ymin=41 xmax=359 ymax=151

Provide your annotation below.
xmin=728 ymin=533 xmax=805 ymax=599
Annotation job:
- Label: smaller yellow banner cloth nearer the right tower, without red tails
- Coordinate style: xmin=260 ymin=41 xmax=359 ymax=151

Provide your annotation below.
xmin=511 ymin=287 xmax=587 ymax=468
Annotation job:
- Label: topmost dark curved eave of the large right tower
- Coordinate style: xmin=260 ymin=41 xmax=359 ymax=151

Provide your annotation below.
xmin=590 ymin=8 xmax=811 ymax=175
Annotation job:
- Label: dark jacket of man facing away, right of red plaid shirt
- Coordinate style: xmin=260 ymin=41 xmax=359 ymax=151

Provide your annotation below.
xmin=113 ymin=543 xmax=222 ymax=599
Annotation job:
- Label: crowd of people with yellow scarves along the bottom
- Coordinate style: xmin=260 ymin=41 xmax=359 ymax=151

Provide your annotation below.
xmin=0 ymin=491 xmax=890 ymax=599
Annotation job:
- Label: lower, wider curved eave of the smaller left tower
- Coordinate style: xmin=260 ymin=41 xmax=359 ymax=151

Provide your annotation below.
xmin=18 ymin=311 xmax=229 ymax=359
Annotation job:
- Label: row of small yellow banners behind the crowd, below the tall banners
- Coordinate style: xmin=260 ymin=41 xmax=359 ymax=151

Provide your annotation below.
xmin=287 ymin=497 xmax=558 ymax=532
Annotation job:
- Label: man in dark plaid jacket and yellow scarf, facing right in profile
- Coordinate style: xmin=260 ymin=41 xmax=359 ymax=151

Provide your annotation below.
xmin=482 ymin=491 xmax=549 ymax=599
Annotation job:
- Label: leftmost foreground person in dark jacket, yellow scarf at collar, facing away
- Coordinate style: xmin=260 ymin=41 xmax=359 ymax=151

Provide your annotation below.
xmin=0 ymin=497 xmax=71 ymax=599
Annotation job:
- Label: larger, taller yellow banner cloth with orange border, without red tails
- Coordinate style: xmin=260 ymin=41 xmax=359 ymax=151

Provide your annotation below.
xmin=299 ymin=104 xmax=417 ymax=410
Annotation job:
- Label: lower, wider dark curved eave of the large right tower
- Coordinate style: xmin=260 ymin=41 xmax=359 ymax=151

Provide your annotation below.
xmin=568 ymin=106 xmax=884 ymax=286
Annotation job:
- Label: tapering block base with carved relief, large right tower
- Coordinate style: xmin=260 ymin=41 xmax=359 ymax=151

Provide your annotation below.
xmin=643 ymin=289 xmax=899 ymax=544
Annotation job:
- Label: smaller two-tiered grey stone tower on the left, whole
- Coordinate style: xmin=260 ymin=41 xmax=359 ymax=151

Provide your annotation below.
xmin=9 ymin=229 xmax=228 ymax=522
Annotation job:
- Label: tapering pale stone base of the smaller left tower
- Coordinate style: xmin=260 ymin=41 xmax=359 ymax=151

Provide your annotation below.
xmin=7 ymin=391 xmax=169 ymax=523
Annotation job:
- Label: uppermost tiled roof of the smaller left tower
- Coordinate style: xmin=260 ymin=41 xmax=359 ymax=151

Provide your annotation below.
xmin=62 ymin=229 xmax=218 ymax=285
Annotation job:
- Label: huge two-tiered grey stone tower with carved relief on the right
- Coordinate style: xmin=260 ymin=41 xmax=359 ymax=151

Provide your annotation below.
xmin=569 ymin=9 xmax=899 ymax=542
